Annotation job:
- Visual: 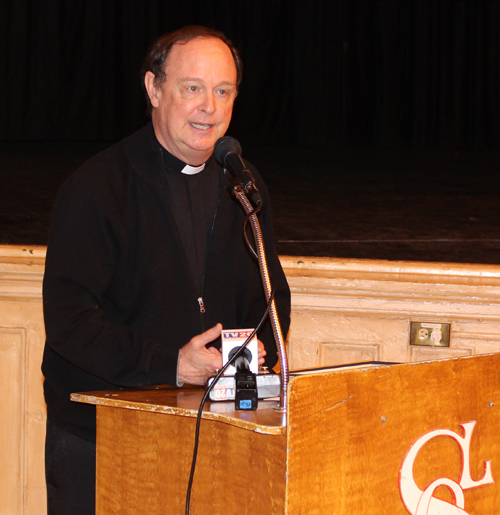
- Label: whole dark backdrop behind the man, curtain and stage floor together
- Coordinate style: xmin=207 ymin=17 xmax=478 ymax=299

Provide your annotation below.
xmin=0 ymin=0 xmax=500 ymax=263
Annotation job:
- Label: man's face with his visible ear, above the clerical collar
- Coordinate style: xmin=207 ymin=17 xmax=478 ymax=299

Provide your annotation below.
xmin=145 ymin=37 xmax=236 ymax=165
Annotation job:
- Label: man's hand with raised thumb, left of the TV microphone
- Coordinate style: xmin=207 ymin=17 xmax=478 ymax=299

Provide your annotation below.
xmin=177 ymin=324 xmax=222 ymax=384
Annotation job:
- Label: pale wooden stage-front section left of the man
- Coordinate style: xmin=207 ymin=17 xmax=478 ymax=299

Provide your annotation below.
xmin=0 ymin=246 xmax=47 ymax=515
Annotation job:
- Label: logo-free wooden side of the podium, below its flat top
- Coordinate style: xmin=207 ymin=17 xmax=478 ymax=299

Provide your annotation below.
xmin=96 ymin=394 xmax=286 ymax=515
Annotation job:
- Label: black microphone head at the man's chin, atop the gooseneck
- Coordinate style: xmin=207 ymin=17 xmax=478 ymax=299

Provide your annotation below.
xmin=214 ymin=136 xmax=262 ymax=207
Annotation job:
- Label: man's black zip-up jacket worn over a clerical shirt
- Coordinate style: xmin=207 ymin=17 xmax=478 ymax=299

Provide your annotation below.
xmin=42 ymin=126 xmax=290 ymax=440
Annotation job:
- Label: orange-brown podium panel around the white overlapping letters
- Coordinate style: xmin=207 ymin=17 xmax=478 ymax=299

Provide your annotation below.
xmin=287 ymin=355 xmax=500 ymax=515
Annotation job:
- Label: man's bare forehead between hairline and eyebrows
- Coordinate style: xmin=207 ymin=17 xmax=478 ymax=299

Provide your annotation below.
xmin=165 ymin=37 xmax=236 ymax=83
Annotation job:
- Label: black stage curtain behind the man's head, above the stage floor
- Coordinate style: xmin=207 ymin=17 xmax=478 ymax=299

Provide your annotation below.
xmin=0 ymin=0 xmax=500 ymax=149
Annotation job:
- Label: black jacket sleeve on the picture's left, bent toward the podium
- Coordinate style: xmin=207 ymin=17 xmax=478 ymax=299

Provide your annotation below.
xmin=43 ymin=164 xmax=178 ymax=386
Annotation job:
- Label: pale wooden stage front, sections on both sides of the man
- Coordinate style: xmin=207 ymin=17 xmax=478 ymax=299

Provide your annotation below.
xmin=0 ymin=246 xmax=500 ymax=515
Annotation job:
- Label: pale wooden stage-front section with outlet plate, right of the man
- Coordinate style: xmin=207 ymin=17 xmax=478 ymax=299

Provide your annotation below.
xmin=281 ymin=257 xmax=500 ymax=369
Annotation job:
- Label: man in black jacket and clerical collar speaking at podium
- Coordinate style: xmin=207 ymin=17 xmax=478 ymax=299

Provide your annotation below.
xmin=42 ymin=27 xmax=290 ymax=515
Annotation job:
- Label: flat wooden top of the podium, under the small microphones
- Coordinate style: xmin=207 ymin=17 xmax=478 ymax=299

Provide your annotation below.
xmin=71 ymin=386 xmax=286 ymax=435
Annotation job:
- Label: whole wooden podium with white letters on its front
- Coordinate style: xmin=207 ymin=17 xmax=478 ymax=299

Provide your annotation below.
xmin=73 ymin=355 xmax=500 ymax=515
